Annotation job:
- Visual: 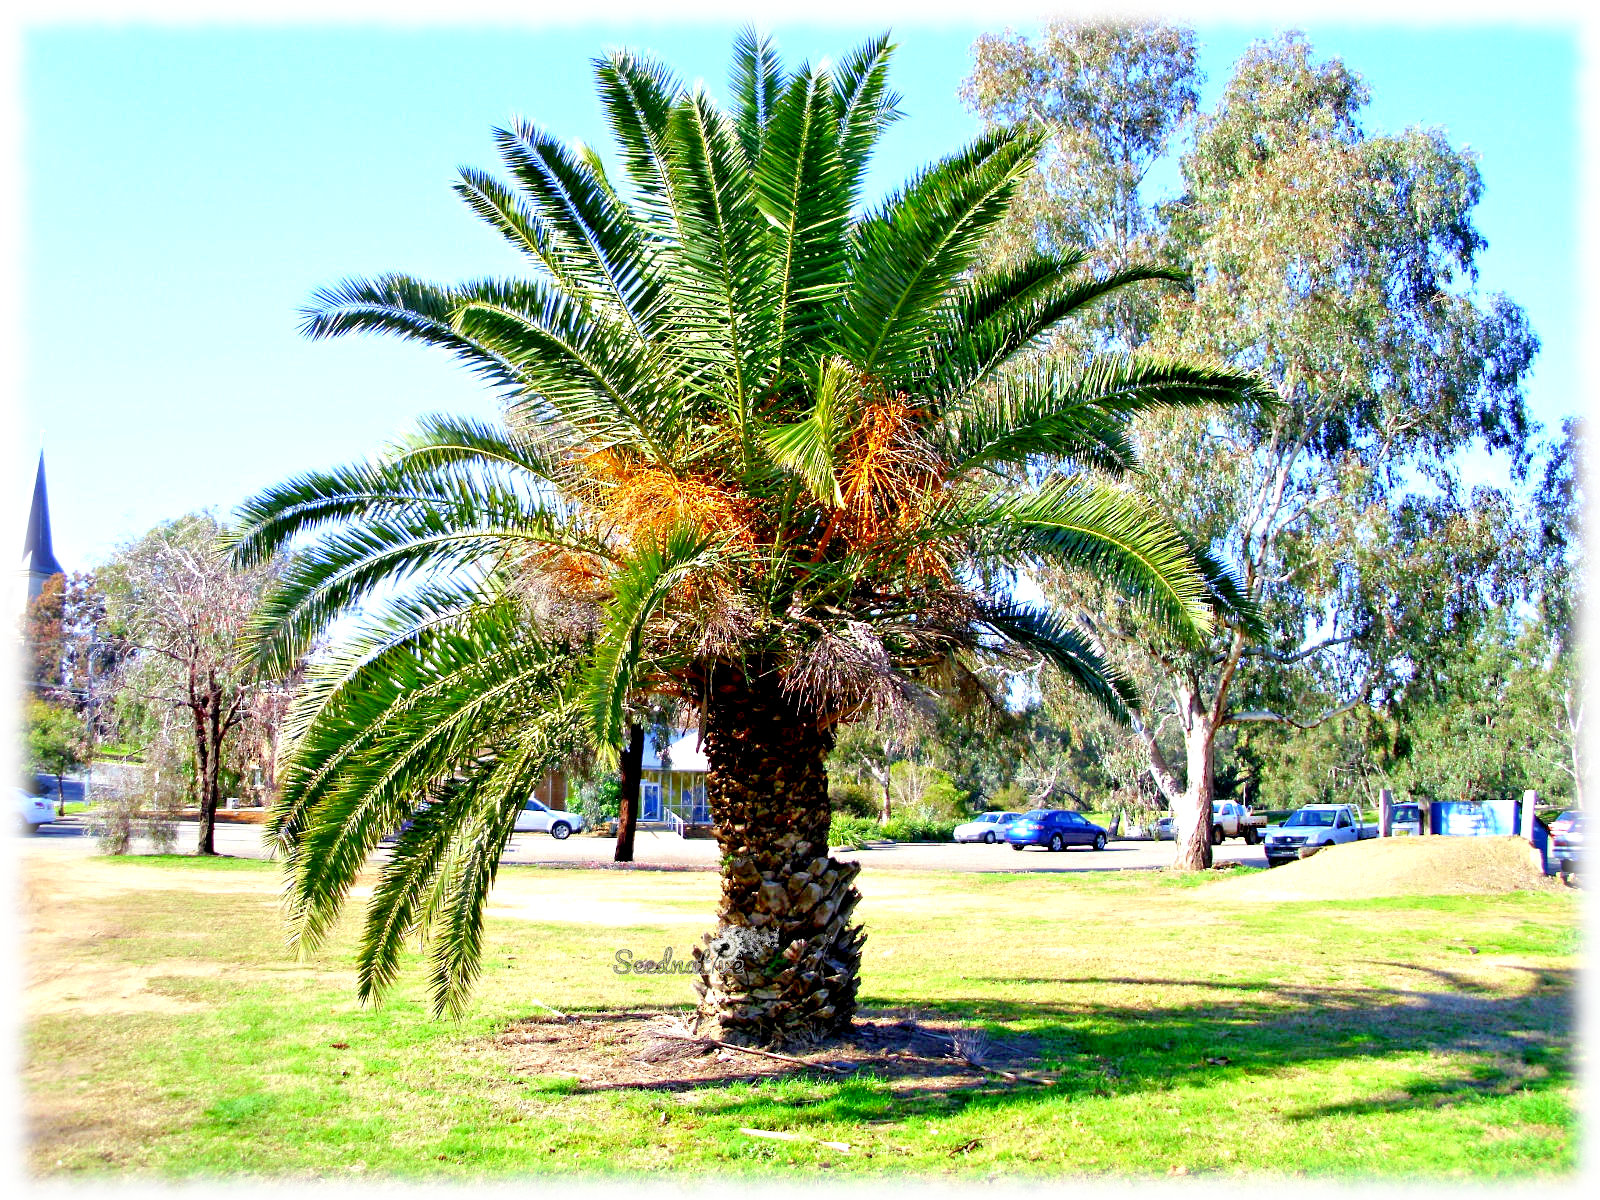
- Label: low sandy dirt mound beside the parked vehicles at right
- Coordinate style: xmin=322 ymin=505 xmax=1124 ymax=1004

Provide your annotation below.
xmin=1214 ymin=837 xmax=1563 ymax=901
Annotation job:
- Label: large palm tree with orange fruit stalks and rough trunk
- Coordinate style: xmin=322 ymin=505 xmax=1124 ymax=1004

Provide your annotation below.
xmin=235 ymin=32 xmax=1262 ymax=1043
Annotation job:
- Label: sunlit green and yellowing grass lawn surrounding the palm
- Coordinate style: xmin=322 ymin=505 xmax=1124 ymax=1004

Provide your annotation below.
xmin=24 ymin=858 xmax=1581 ymax=1179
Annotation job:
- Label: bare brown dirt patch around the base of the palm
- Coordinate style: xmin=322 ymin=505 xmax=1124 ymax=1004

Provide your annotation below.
xmin=493 ymin=1010 xmax=1051 ymax=1091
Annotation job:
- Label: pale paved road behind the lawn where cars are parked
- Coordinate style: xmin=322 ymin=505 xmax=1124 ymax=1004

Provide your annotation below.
xmin=18 ymin=816 xmax=1267 ymax=872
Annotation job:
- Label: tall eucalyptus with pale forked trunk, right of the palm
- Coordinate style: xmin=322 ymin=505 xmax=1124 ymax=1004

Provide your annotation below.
xmin=989 ymin=34 xmax=1538 ymax=867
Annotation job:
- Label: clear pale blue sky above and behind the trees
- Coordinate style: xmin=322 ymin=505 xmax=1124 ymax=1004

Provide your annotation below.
xmin=8 ymin=19 xmax=1581 ymax=570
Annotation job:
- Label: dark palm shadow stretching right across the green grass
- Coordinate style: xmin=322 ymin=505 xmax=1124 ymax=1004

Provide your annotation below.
xmin=547 ymin=963 xmax=1576 ymax=1126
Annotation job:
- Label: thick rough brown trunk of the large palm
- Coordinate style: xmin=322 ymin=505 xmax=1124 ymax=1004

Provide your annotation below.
xmin=694 ymin=664 xmax=866 ymax=1045
